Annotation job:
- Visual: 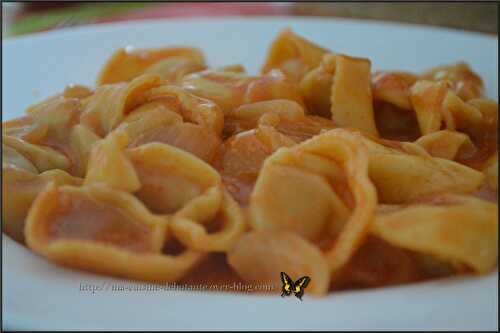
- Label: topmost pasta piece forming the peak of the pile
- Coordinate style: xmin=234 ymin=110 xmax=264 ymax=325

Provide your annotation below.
xmin=261 ymin=29 xmax=328 ymax=82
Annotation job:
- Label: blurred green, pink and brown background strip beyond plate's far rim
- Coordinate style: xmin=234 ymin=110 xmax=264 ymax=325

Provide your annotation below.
xmin=2 ymin=1 xmax=498 ymax=38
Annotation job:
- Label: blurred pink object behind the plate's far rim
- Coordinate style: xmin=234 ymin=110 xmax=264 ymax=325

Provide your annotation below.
xmin=97 ymin=3 xmax=292 ymax=23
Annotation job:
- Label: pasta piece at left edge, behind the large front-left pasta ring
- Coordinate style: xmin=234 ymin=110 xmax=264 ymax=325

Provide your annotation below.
xmin=2 ymin=167 xmax=82 ymax=243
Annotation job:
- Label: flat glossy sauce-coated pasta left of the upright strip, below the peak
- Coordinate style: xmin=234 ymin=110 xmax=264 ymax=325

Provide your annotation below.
xmin=182 ymin=70 xmax=303 ymax=114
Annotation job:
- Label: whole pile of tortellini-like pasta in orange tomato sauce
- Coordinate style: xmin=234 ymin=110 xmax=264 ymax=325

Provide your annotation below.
xmin=2 ymin=29 xmax=498 ymax=296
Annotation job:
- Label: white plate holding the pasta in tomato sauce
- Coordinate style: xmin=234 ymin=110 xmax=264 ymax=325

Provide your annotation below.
xmin=2 ymin=18 xmax=498 ymax=330
